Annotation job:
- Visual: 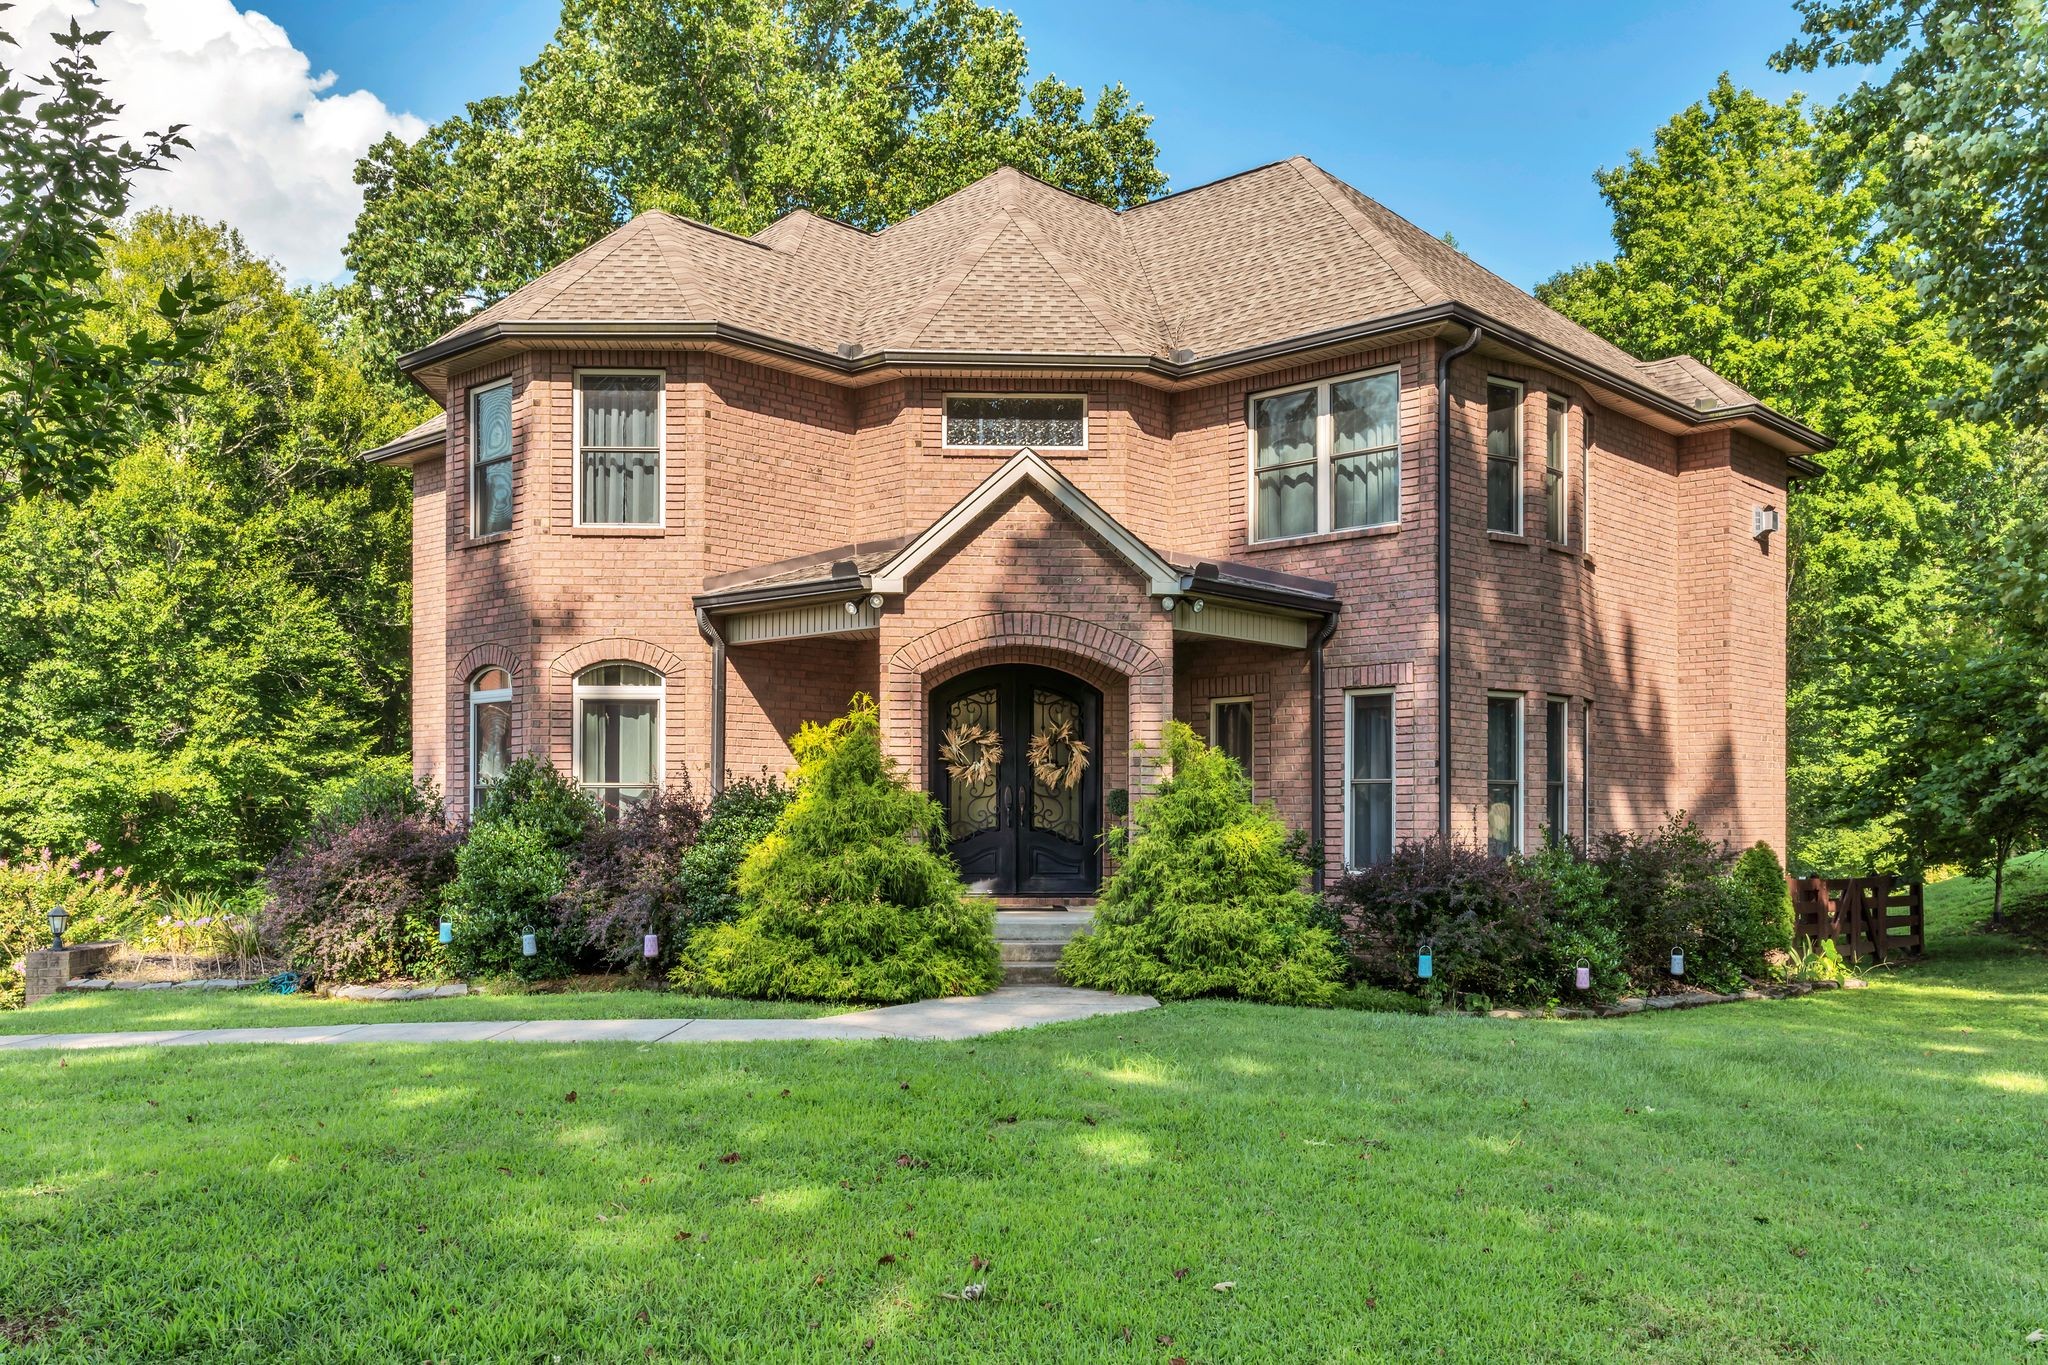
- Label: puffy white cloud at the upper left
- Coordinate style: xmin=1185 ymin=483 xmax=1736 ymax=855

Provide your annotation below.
xmin=0 ymin=0 xmax=426 ymax=282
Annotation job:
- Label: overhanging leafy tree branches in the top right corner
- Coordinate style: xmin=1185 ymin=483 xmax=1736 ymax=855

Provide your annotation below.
xmin=1772 ymin=0 xmax=2048 ymax=426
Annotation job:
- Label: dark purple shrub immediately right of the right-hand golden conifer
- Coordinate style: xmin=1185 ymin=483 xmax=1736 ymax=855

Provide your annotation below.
xmin=1329 ymin=839 xmax=1548 ymax=1001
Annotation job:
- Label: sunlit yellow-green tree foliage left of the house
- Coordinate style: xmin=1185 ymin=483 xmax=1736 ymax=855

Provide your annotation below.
xmin=0 ymin=213 xmax=420 ymax=888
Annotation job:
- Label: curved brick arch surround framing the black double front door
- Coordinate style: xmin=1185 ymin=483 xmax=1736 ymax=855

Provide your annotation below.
xmin=883 ymin=612 xmax=1174 ymax=796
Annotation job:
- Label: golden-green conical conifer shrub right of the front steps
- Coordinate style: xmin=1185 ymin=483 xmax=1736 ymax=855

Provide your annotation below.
xmin=1059 ymin=720 xmax=1343 ymax=1005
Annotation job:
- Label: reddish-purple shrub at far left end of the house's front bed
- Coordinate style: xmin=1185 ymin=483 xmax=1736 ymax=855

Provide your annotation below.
xmin=262 ymin=812 xmax=457 ymax=982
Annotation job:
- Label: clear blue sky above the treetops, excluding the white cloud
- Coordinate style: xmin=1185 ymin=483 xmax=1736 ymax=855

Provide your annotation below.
xmin=266 ymin=0 xmax=1845 ymax=287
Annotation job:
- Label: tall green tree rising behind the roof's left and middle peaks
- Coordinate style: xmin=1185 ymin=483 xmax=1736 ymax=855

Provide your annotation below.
xmin=348 ymin=0 xmax=1165 ymax=352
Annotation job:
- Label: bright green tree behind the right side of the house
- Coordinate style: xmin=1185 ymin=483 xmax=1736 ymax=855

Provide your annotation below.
xmin=1538 ymin=78 xmax=2015 ymax=872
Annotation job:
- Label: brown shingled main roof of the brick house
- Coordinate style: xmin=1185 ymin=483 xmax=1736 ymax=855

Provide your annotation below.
xmin=422 ymin=158 xmax=1810 ymax=437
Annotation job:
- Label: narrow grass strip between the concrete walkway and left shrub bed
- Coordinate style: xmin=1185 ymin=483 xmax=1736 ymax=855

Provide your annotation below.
xmin=0 ymin=988 xmax=852 ymax=1036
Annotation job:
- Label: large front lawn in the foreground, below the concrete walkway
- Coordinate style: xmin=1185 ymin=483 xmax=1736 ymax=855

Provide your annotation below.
xmin=0 ymin=860 xmax=2048 ymax=1363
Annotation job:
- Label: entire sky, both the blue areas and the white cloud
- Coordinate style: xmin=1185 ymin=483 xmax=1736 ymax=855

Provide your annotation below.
xmin=28 ymin=0 xmax=1849 ymax=287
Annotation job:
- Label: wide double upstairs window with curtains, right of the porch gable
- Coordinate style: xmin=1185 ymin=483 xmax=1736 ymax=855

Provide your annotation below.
xmin=1251 ymin=370 xmax=1401 ymax=540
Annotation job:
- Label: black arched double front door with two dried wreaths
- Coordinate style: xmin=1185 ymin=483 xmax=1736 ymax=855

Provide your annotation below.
xmin=926 ymin=665 xmax=1102 ymax=896
